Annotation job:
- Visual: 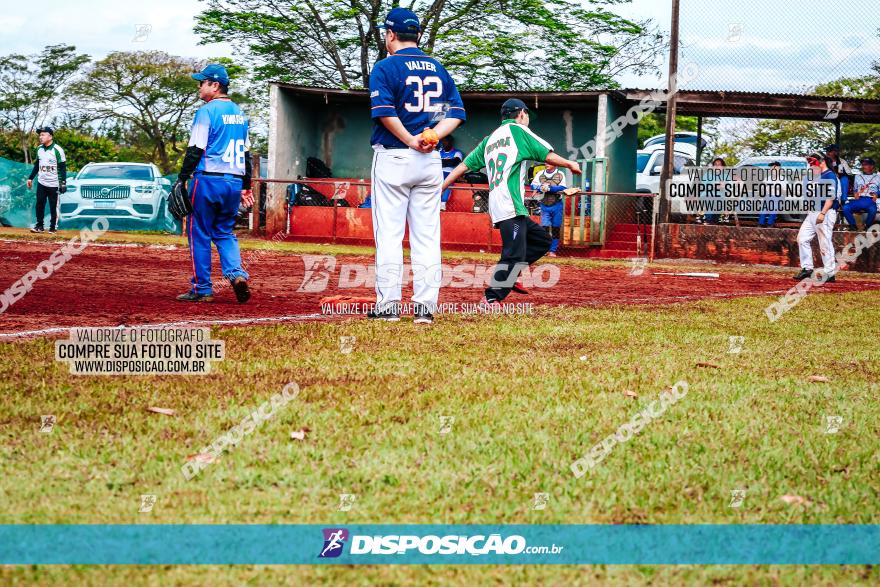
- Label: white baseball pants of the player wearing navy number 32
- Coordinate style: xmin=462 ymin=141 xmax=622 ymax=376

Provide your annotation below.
xmin=371 ymin=145 xmax=443 ymax=311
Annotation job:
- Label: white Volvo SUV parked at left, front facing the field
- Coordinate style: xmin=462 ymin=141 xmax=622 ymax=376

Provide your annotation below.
xmin=58 ymin=163 xmax=174 ymax=230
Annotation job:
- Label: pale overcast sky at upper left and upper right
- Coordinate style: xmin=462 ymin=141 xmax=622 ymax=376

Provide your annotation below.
xmin=0 ymin=0 xmax=880 ymax=92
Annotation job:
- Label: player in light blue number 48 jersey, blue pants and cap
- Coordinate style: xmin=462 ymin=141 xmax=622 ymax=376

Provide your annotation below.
xmin=177 ymin=63 xmax=254 ymax=304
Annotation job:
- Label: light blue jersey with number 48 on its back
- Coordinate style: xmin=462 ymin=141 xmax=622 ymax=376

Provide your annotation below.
xmin=189 ymin=99 xmax=251 ymax=177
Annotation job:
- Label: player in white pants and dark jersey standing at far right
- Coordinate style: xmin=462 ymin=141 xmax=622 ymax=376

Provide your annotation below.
xmin=794 ymin=154 xmax=840 ymax=283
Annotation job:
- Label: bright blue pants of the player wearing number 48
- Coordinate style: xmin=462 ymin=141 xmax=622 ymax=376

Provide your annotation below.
xmin=187 ymin=173 xmax=248 ymax=295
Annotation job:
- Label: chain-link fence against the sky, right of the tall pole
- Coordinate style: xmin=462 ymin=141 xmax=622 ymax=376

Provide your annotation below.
xmin=679 ymin=0 xmax=880 ymax=95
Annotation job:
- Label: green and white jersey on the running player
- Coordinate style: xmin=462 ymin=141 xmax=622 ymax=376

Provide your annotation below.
xmin=464 ymin=119 xmax=553 ymax=224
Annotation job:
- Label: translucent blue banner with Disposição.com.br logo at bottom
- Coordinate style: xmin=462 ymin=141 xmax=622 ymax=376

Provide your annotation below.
xmin=0 ymin=524 xmax=880 ymax=565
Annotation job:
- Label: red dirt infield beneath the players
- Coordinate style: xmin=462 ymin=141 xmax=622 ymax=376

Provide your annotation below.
xmin=0 ymin=240 xmax=880 ymax=341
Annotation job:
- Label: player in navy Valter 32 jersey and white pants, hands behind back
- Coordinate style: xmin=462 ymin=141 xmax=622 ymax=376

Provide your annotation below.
xmin=368 ymin=8 xmax=465 ymax=324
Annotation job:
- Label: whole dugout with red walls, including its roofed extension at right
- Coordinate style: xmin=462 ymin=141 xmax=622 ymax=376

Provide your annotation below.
xmin=255 ymin=82 xmax=880 ymax=270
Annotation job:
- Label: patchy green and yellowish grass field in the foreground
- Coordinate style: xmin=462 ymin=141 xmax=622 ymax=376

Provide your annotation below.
xmin=0 ymin=255 xmax=880 ymax=585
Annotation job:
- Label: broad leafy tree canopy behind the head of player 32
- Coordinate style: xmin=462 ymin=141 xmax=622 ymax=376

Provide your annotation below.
xmin=195 ymin=0 xmax=665 ymax=91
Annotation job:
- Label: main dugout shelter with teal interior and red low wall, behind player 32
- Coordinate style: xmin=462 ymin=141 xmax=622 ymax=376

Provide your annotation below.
xmin=263 ymin=82 xmax=638 ymax=250
